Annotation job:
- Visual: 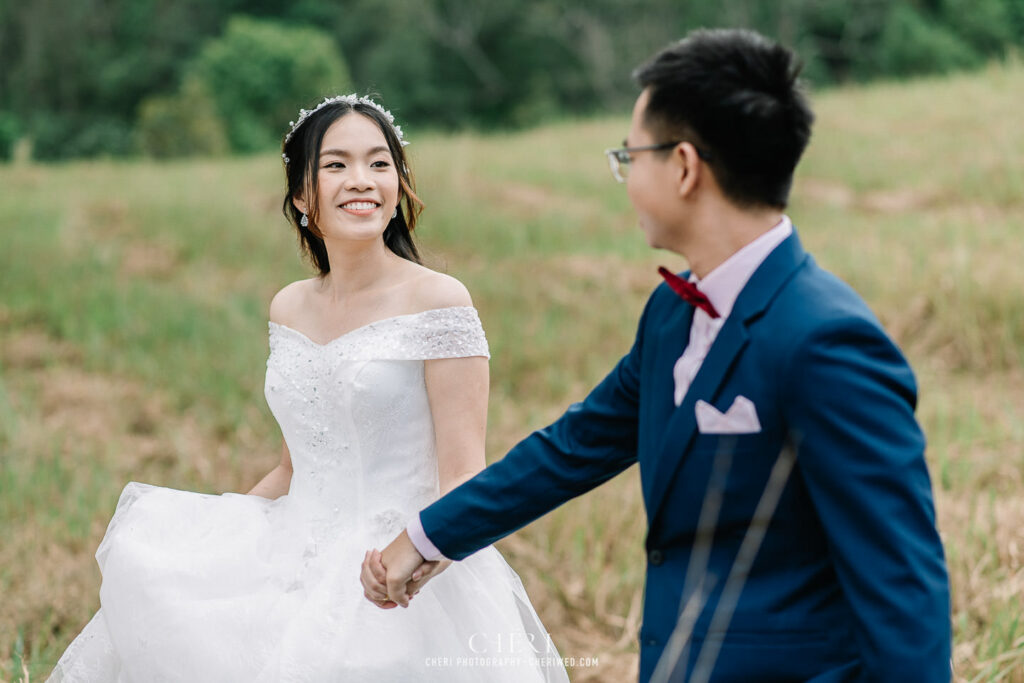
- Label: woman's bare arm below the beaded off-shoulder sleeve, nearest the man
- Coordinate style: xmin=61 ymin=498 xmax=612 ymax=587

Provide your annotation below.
xmin=424 ymin=356 xmax=489 ymax=496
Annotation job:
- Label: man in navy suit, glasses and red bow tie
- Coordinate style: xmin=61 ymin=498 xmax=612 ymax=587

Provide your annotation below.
xmin=362 ymin=30 xmax=950 ymax=683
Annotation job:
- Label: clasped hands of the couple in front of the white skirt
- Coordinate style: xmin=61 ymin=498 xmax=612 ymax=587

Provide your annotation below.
xmin=359 ymin=531 xmax=452 ymax=609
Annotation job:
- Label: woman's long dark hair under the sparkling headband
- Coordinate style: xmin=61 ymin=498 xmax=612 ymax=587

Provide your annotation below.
xmin=282 ymin=101 xmax=423 ymax=275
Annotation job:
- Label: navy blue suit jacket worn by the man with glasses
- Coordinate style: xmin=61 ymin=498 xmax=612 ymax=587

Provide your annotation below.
xmin=420 ymin=233 xmax=950 ymax=683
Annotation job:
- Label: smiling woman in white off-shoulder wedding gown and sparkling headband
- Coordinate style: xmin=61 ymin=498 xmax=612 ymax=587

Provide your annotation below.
xmin=50 ymin=95 xmax=567 ymax=683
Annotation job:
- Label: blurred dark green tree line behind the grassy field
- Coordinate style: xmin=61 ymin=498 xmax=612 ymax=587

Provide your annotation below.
xmin=0 ymin=0 xmax=1024 ymax=160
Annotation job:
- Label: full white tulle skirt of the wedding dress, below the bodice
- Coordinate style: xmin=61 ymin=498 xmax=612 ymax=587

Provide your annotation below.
xmin=50 ymin=483 xmax=568 ymax=683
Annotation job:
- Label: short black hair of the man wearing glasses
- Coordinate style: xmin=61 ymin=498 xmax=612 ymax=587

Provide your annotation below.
xmin=633 ymin=29 xmax=814 ymax=208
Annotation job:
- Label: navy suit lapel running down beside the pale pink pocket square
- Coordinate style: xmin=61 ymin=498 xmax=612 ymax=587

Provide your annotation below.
xmin=647 ymin=229 xmax=807 ymax=525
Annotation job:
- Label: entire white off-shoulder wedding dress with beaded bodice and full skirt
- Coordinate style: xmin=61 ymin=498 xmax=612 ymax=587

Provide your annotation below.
xmin=50 ymin=307 xmax=568 ymax=683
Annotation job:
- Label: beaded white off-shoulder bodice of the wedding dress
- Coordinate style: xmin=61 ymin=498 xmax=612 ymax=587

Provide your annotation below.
xmin=264 ymin=306 xmax=488 ymax=536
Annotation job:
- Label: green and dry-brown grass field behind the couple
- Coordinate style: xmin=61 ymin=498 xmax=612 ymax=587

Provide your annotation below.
xmin=0 ymin=65 xmax=1024 ymax=683
